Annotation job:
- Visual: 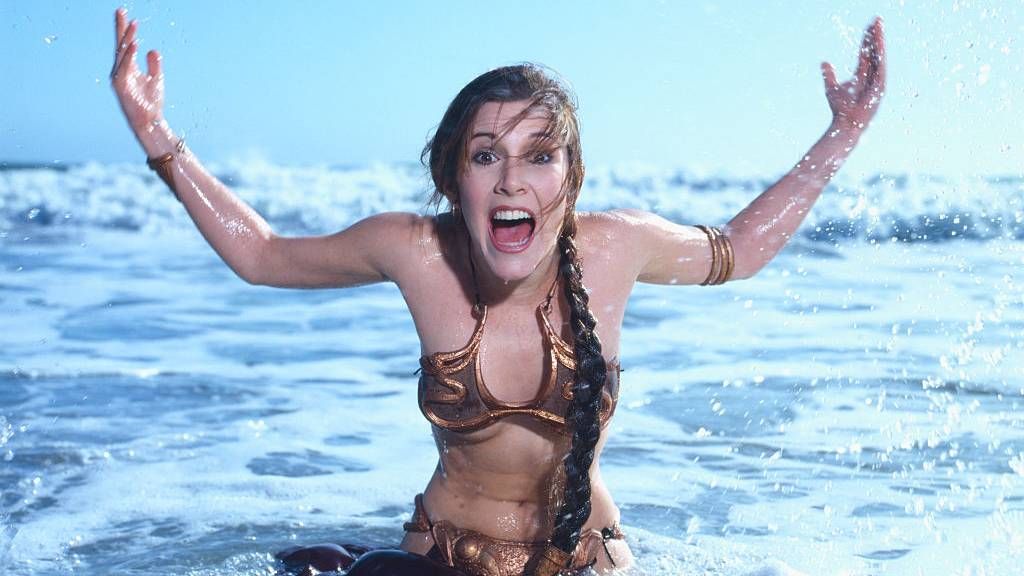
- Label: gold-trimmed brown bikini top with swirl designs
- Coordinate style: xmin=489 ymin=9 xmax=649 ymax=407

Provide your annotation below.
xmin=419 ymin=271 xmax=621 ymax=434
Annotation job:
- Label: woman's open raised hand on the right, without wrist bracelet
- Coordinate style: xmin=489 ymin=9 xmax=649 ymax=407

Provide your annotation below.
xmin=821 ymin=17 xmax=886 ymax=133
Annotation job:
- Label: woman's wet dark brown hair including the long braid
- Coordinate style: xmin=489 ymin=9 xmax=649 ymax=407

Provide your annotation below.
xmin=421 ymin=64 xmax=606 ymax=565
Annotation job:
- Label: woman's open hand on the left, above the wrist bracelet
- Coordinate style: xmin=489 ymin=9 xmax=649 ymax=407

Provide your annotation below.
xmin=111 ymin=8 xmax=164 ymax=139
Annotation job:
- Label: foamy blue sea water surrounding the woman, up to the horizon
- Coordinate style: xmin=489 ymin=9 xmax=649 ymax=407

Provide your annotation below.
xmin=0 ymin=159 xmax=1024 ymax=576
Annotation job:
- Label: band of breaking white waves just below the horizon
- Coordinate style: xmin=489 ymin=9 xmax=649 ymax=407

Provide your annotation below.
xmin=0 ymin=163 xmax=1024 ymax=243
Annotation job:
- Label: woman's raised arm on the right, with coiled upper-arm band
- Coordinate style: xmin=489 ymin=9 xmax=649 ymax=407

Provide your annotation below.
xmin=620 ymin=18 xmax=886 ymax=284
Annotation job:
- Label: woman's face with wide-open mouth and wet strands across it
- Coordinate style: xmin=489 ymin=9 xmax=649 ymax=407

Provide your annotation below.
xmin=459 ymin=101 xmax=567 ymax=282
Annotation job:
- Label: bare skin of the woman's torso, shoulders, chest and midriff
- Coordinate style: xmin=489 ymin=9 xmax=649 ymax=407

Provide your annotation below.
xmin=395 ymin=214 xmax=636 ymax=565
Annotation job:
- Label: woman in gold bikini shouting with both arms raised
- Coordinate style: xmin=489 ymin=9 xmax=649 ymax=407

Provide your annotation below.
xmin=112 ymin=9 xmax=885 ymax=575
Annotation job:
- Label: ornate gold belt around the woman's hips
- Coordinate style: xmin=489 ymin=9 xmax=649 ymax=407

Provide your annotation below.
xmin=403 ymin=494 xmax=626 ymax=576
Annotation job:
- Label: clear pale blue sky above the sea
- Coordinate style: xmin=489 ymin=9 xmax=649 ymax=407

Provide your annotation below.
xmin=0 ymin=0 xmax=1024 ymax=175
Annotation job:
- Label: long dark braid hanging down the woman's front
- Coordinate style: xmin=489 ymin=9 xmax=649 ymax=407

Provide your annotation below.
xmin=551 ymin=228 xmax=607 ymax=554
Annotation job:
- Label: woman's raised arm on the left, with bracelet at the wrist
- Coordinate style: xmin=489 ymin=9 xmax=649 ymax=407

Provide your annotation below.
xmin=111 ymin=8 xmax=422 ymax=288
